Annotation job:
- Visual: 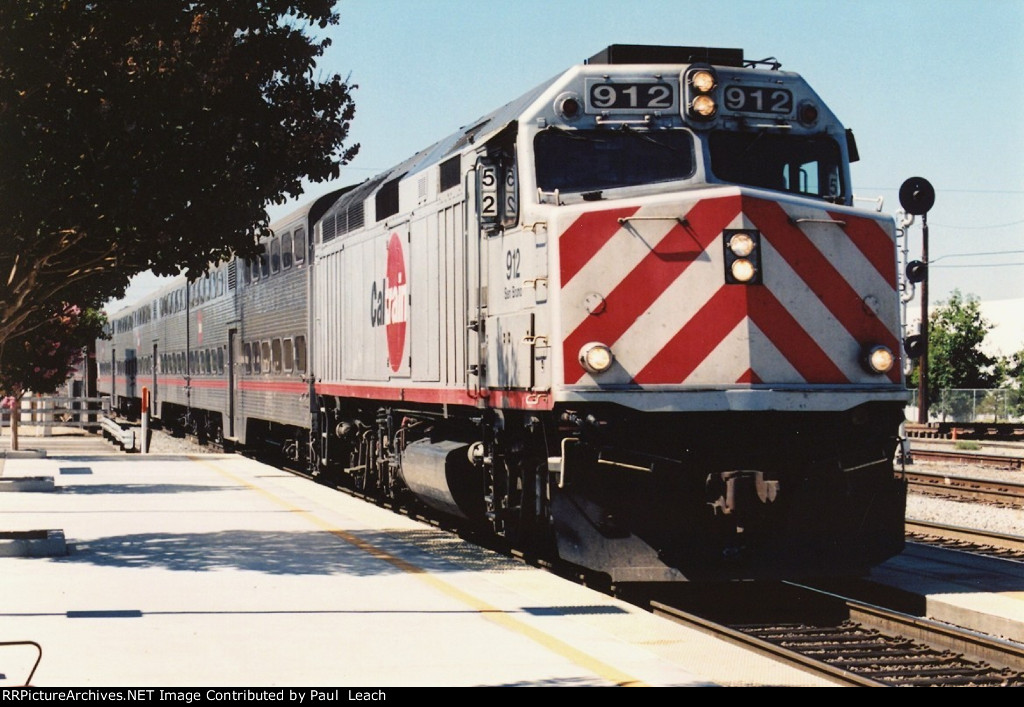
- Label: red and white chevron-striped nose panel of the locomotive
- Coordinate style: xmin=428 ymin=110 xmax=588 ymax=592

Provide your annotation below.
xmin=558 ymin=193 xmax=900 ymax=386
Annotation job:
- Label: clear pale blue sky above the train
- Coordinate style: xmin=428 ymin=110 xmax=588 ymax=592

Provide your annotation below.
xmin=121 ymin=0 xmax=1024 ymax=311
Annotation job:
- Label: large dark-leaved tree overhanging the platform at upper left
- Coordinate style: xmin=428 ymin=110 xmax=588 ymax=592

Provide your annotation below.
xmin=0 ymin=0 xmax=358 ymax=346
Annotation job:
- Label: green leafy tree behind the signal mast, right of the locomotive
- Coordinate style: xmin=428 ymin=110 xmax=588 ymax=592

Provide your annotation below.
xmin=911 ymin=290 xmax=998 ymax=413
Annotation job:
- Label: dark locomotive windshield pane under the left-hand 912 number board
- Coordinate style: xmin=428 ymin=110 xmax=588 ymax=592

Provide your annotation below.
xmin=534 ymin=128 xmax=695 ymax=193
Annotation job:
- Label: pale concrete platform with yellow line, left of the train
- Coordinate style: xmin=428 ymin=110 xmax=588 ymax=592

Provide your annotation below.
xmin=0 ymin=452 xmax=839 ymax=689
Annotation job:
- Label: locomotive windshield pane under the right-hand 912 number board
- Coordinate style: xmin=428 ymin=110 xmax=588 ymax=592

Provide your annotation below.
xmin=711 ymin=131 xmax=843 ymax=202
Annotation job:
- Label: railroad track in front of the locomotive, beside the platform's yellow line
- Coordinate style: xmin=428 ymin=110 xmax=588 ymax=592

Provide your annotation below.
xmin=650 ymin=584 xmax=1024 ymax=687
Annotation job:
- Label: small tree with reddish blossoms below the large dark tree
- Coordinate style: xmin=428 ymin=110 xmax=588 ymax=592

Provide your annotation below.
xmin=0 ymin=304 xmax=106 ymax=450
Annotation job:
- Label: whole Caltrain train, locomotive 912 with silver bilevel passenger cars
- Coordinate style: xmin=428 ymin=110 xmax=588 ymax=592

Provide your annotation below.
xmin=97 ymin=45 xmax=906 ymax=583
